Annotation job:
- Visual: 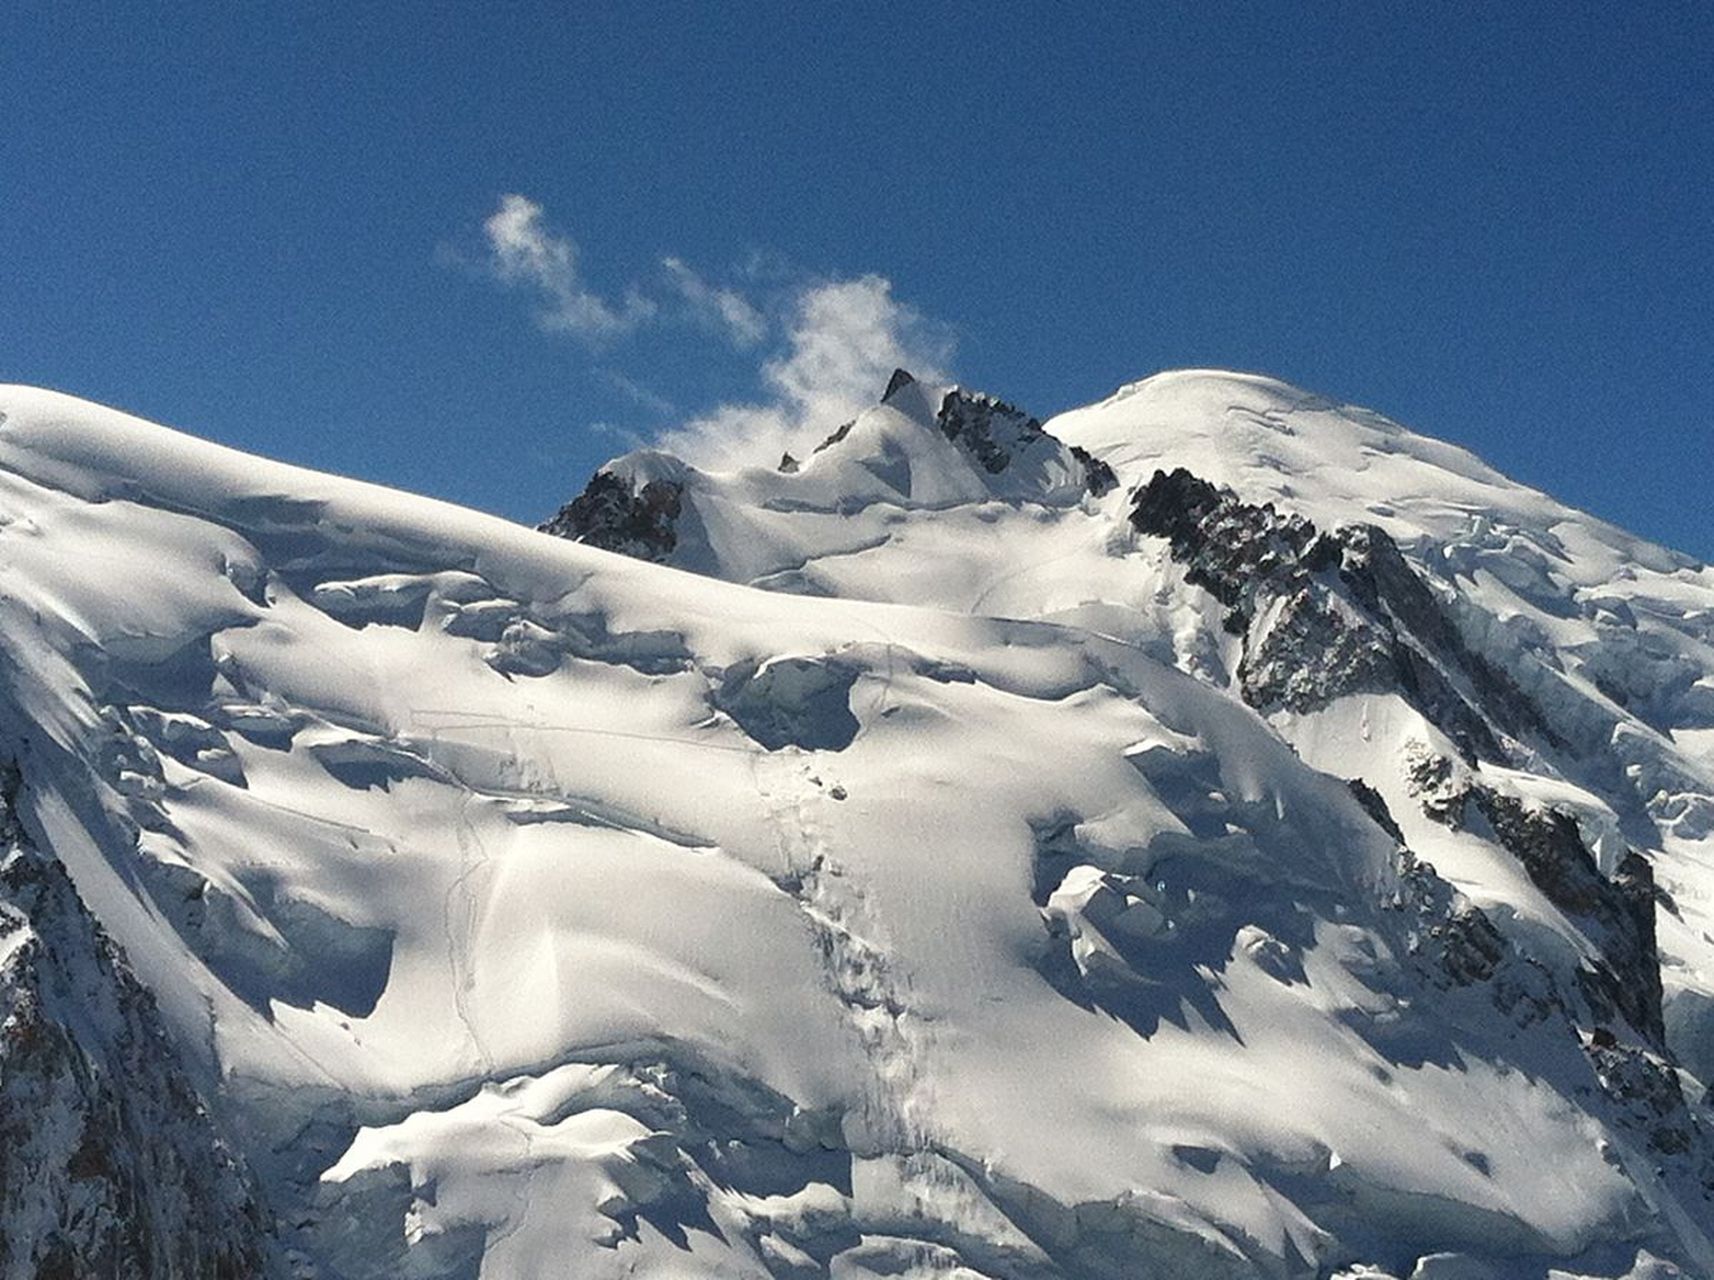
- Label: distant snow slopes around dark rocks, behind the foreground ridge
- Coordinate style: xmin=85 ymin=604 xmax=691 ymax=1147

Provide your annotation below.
xmin=569 ymin=370 xmax=1714 ymax=1103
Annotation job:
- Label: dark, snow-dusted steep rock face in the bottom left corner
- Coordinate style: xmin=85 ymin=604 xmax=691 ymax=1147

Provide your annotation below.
xmin=0 ymin=773 xmax=273 ymax=1280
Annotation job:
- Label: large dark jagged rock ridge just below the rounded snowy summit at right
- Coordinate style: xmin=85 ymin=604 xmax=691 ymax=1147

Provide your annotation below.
xmin=1131 ymin=468 xmax=1546 ymax=761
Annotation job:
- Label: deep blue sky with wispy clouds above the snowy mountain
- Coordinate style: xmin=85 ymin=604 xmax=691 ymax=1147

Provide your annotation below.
xmin=0 ymin=0 xmax=1714 ymax=559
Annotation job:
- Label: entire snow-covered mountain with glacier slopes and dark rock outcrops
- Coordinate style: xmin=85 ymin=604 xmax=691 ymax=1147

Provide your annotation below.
xmin=0 ymin=372 xmax=1714 ymax=1280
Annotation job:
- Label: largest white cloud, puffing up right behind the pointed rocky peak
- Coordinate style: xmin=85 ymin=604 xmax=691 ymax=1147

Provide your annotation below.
xmin=660 ymin=276 xmax=953 ymax=468
